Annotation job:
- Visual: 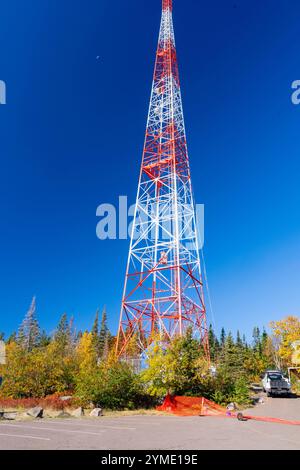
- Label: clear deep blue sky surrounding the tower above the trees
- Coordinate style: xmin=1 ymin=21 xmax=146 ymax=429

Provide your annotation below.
xmin=0 ymin=0 xmax=300 ymax=335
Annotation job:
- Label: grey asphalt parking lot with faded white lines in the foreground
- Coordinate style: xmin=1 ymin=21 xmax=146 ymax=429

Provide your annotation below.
xmin=0 ymin=398 xmax=300 ymax=450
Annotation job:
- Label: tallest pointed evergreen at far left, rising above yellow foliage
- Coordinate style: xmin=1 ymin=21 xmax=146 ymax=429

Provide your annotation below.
xmin=18 ymin=297 xmax=41 ymax=351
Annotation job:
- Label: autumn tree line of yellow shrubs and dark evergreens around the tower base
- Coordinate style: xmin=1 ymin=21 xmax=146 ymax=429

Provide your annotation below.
xmin=0 ymin=298 xmax=300 ymax=409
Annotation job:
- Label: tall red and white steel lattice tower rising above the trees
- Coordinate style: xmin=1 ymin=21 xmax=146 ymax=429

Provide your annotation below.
xmin=117 ymin=0 xmax=209 ymax=358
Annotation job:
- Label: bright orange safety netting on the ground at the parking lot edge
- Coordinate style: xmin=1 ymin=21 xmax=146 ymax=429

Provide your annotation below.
xmin=157 ymin=395 xmax=300 ymax=426
